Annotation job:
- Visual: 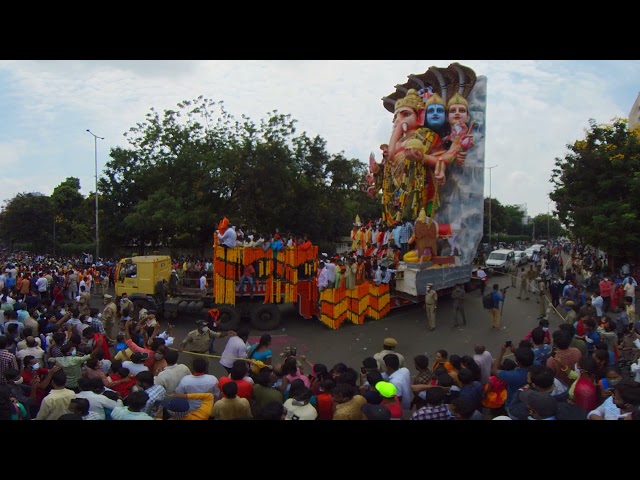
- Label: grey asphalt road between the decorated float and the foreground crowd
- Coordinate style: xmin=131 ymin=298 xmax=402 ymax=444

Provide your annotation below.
xmin=92 ymin=268 xmax=559 ymax=377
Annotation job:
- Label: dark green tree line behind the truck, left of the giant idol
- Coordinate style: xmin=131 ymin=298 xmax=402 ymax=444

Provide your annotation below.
xmin=0 ymin=96 xmax=380 ymax=256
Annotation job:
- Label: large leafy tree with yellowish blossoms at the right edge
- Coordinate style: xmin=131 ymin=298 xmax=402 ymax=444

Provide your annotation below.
xmin=549 ymin=119 xmax=640 ymax=256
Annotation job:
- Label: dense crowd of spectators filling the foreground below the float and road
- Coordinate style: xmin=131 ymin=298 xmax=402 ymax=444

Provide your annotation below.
xmin=0 ymin=240 xmax=640 ymax=420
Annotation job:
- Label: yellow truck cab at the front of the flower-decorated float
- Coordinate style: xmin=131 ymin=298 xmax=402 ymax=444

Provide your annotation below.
xmin=115 ymin=255 xmax=171 ymax=310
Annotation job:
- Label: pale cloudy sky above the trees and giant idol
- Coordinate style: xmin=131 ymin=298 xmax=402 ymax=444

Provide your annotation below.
xmin=0 ymin=59 xmax=640 ymax=216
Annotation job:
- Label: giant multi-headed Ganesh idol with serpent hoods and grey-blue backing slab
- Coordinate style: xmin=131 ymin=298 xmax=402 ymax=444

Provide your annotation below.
xmin=367 ymin=63 xmax=486 ymax=264
